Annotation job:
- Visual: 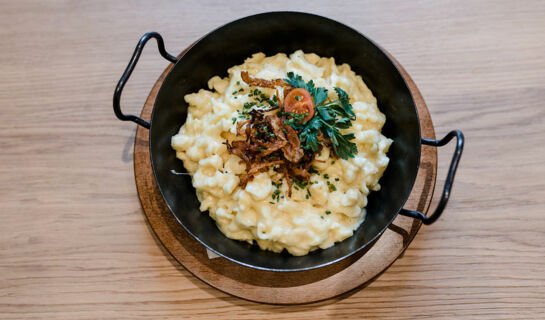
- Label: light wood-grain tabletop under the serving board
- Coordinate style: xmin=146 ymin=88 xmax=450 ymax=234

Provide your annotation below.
xmin=0 ymin=1 xmax=545 ymax=319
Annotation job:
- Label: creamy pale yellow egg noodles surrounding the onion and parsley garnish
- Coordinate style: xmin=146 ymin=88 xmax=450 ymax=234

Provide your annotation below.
xmin=171 ymin=51 xmax=392 ymax=256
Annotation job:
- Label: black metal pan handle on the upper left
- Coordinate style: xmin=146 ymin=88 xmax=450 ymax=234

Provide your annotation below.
xmin=114 ymin=31 xmax=178 ymax=129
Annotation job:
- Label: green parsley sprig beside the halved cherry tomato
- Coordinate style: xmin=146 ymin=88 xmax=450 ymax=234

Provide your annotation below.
xmin=284 ymin=72 xmax=358 ymax=159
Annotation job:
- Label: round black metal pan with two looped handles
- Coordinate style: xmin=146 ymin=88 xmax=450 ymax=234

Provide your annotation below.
xmin=113 ymin=12 xmax=464 ymax=271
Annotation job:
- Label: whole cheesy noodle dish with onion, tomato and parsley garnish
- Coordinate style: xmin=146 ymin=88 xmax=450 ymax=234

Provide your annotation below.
xmin=171 ymin=51 xmax=392 ymax=256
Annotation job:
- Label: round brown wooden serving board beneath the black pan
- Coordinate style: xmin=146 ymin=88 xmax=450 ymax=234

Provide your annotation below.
xmin=134 ymin=51 xmax=437 ymax=304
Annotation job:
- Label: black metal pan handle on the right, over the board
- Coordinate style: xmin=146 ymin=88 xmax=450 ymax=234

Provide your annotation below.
xmin=399 ymin=130 xmax=464 ymax=225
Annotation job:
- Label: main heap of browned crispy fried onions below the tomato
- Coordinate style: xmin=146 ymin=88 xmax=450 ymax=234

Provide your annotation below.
xmin=225 ymin=109 xmax=315 ymax=196
